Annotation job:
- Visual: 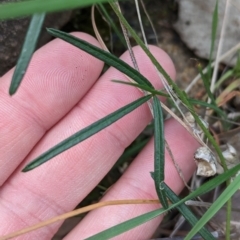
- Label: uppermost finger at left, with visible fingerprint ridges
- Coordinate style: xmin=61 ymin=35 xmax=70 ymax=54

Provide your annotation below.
xmin=0 ymin=33 xmax=103 ymax=186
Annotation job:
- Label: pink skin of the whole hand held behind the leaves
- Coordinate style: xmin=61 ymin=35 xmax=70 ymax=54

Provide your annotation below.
xmin=0 ymin=33 xmax=198 ymax=240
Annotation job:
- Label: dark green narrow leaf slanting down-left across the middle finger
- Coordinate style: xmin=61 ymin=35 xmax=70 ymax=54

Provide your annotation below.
xmin=22 ymin=95 xmax=152 ymax=172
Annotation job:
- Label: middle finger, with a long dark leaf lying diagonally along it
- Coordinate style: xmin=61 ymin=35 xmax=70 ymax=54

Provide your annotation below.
xmin=0 ymin=47 xmax=175 ymax=239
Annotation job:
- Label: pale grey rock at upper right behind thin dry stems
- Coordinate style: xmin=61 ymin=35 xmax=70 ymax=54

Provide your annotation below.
xmin=174 ymin=0 xmax=240 ymax=65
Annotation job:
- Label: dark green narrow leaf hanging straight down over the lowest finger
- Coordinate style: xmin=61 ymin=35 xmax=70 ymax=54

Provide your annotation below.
xmin=153 ymin=96 xmax=168 ymax=209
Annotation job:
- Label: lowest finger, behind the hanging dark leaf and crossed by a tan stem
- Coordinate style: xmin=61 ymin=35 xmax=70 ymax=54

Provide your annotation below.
xmin=65 ymin=120 xmax=198 ymax=240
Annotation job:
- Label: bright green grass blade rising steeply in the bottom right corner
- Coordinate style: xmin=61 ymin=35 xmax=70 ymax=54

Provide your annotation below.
xmin=185 ymin=172 xmax=240 ymax=240
